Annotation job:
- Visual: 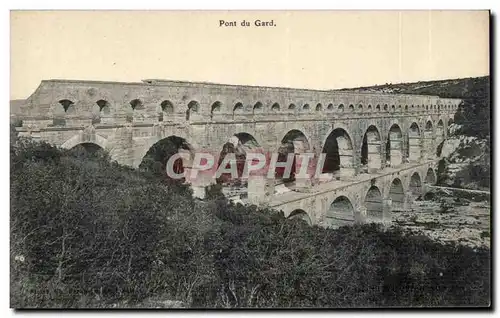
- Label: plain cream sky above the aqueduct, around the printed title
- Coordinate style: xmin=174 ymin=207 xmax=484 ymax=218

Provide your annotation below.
xmin=10 ymin=11 xmax=489 ymax=99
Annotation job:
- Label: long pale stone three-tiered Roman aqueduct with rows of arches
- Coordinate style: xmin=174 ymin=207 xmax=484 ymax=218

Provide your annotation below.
xmin=17 ymin=80 xmax=461 ymax=227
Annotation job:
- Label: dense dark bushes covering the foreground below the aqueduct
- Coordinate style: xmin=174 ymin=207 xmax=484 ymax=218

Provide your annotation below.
xmin=11 ymin=141 xmax=490 ymax=308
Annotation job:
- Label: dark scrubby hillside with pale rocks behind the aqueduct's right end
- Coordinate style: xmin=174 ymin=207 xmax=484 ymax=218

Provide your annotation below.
xmin=341 ymin=76 xmax=491 ymax=189
